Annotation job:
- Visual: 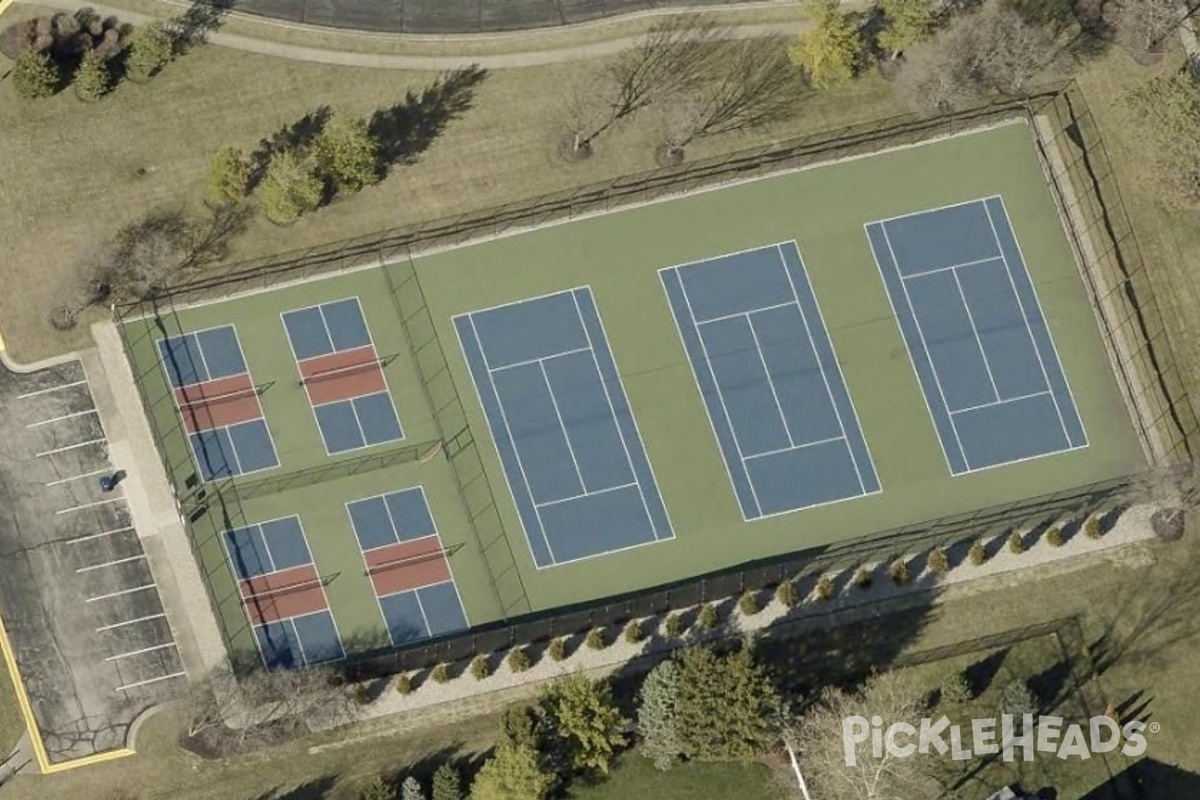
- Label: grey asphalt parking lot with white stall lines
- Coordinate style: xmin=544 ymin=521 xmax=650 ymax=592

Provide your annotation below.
xmin=0 ymin=361 xmax=186 ymax=763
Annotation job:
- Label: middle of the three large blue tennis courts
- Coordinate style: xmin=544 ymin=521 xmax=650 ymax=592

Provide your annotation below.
xmin=659 ymin=242 xmax=880 ymax=521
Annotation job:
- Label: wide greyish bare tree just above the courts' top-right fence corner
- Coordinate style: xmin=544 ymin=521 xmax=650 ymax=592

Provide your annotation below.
xmin=896 ymin=8 xmax=1060 ymax=115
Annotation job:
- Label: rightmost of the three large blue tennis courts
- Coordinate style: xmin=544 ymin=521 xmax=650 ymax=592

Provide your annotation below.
xmin=866 ymin=197 xmax=1087 ymax=475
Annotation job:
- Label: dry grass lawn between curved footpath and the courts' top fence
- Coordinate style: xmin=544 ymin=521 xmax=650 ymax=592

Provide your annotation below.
xmin=0 ymin=13 xmax=899 ymax=361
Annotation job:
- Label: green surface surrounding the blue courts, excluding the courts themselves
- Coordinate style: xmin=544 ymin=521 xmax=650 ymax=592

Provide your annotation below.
xmin=125 ymin=124 xmax=1142 ymax=666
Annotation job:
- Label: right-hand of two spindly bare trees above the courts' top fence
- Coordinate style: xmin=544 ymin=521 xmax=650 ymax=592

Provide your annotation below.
xmin=659 ymin=36 xmax=805 ymax=158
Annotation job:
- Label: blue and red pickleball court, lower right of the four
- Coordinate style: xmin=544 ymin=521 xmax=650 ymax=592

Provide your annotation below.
xmin=346 ymin=486 xmax=469 ymax=646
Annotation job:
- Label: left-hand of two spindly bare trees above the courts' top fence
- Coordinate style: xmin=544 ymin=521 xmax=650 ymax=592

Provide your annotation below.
xmin=563 ymin=16 xmax=726 ymax=157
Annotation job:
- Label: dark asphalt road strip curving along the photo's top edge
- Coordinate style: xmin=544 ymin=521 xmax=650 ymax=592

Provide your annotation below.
xmin=226 ymin=0 xmax=752 ymax=34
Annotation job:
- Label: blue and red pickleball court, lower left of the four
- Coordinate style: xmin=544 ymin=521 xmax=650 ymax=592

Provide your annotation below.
xmin=223 ymin=516 xmax=346 ymax=669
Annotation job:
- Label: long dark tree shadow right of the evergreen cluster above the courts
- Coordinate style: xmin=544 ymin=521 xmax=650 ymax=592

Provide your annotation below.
xmin=367 ymin=65 xmax=487 ymax=175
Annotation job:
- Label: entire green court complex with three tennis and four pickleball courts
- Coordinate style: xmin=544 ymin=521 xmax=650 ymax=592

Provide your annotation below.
xmin=122 ymin=122 xmax=1144 ymax=666
